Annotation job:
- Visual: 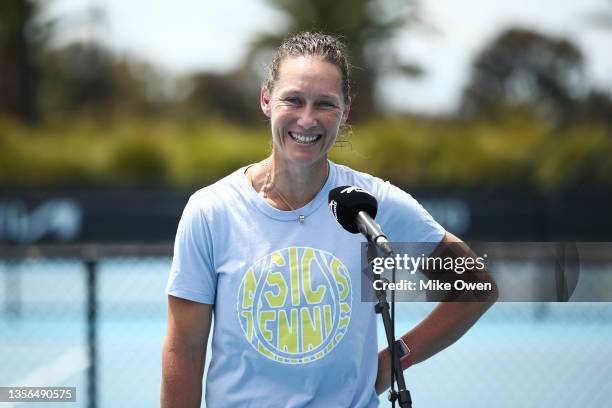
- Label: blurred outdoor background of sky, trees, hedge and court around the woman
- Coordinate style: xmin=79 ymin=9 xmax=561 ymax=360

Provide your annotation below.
xmin=0 ymin=0 xmax=612 ymax=407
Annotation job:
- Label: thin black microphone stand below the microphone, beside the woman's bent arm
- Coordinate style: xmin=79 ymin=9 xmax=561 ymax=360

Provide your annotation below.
xmin=367 ymin=241 xmax=412 ymax=408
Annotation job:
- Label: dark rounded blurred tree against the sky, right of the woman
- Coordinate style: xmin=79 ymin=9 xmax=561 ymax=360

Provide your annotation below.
xmin=462 ymin=29 xmax=585 ymax=126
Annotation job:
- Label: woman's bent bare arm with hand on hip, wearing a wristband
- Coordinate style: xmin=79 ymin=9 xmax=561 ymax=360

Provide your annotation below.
xmin=376 ymin=232 xmax=497 ymax=394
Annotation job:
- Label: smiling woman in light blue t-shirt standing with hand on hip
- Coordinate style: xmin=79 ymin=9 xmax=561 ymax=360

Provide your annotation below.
xmin=161 ymin=32 xmax=491 ymax=407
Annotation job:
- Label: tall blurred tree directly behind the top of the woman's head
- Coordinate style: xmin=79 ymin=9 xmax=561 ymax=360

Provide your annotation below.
xmin=247 ymin=0 xmax=420 ymax=118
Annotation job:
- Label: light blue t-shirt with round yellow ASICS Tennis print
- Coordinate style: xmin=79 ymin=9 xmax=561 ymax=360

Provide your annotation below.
xmin=166 ymin=162 xmax=444 ymax=408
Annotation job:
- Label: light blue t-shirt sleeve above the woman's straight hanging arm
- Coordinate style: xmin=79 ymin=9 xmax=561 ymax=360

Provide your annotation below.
xmin=166 ymin=196 xmax=217 ymax=304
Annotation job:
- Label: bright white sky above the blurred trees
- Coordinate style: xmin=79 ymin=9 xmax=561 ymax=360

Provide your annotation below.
xmin=44 ymin=0 xmax=612 ymax=114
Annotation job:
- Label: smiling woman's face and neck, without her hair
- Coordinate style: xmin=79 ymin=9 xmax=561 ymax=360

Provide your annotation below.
xmin=255 ymin=56 xmax=349 ymax=210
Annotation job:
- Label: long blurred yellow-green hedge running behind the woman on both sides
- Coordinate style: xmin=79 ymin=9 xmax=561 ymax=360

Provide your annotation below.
xmin=0 ymin=110 xmax=612 ymax=190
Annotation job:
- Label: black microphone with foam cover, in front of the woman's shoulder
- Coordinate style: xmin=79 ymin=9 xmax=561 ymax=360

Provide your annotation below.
xmin=328 ymin=186 xmax=394 ymax=255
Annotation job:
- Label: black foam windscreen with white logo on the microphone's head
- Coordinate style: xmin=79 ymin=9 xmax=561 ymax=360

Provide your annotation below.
xmin=328 ymin=186 xmax=378 ymax=234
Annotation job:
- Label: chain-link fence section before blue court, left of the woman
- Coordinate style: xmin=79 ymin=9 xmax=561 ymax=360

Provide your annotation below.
xmin=0 ymin=245 xmax=172 ymax=407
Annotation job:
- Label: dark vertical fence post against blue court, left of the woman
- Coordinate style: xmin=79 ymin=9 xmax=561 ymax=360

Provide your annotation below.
xmin=85 ymin=258 xmax=98 ymax=408
